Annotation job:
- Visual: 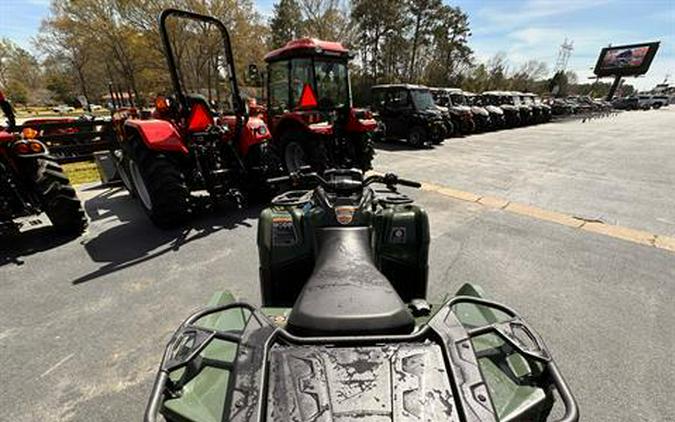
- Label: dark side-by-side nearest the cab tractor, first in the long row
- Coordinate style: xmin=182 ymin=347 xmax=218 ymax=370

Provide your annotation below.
xmin=371 ymin=84 xmax=448 ymax=148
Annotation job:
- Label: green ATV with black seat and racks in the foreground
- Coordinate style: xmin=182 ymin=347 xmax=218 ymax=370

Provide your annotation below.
xmin=145 ymin=170 xmax=579 ymax=422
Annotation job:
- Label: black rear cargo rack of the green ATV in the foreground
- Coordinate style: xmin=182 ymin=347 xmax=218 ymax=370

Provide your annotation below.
xmin=144 ymin=296 xmax=579 ymax=422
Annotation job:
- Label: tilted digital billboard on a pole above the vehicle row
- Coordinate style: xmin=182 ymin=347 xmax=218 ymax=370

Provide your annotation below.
xmin=594 ymin=41 xmax=659 ymax=77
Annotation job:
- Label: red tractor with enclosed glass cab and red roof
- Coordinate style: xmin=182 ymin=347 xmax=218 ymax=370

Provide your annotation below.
xmin=258 ymin=38 xmax=377 ymax=171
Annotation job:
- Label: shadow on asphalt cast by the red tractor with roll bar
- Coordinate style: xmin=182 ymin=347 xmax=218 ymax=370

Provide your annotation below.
xmin=72 ymin=189 xmax=262 ymax=284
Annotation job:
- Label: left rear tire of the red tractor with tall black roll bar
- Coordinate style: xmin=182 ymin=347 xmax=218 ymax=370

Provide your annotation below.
xmin=129 ymin=140 xmax=192 ymax=229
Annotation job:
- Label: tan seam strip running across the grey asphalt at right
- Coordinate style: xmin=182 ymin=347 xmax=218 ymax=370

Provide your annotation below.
xmin=421 ymin=182 xmax=675 ymax=252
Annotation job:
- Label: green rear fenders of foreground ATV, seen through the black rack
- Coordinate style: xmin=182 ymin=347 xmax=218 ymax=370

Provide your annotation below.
xmin=162 ymin=283 xmax=553 ymax=422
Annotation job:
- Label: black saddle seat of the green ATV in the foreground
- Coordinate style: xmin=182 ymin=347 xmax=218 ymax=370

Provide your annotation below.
xmin=288 ymin=227 xmax=415 ymax=336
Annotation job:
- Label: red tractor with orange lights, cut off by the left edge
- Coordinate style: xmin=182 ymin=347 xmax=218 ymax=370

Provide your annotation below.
xmin=0 ymin=92 xmax=87 ymax=235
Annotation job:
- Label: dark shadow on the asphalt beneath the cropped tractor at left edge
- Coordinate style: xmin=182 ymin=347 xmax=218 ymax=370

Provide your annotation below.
xmin=0 ymin=227 xmax=79 ymax=267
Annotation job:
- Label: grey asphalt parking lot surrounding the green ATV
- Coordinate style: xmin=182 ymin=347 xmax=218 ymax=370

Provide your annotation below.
xmin=0 ymin=106 xmax=675 ymax=422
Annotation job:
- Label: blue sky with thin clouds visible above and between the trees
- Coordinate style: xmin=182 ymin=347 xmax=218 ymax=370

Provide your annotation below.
xmin=0 ymin=0 xmax=675 ymax=89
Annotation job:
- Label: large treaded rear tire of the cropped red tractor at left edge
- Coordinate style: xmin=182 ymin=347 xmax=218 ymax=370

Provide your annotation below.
xmin=35 ymin=157 xmax=87 ymax=235
